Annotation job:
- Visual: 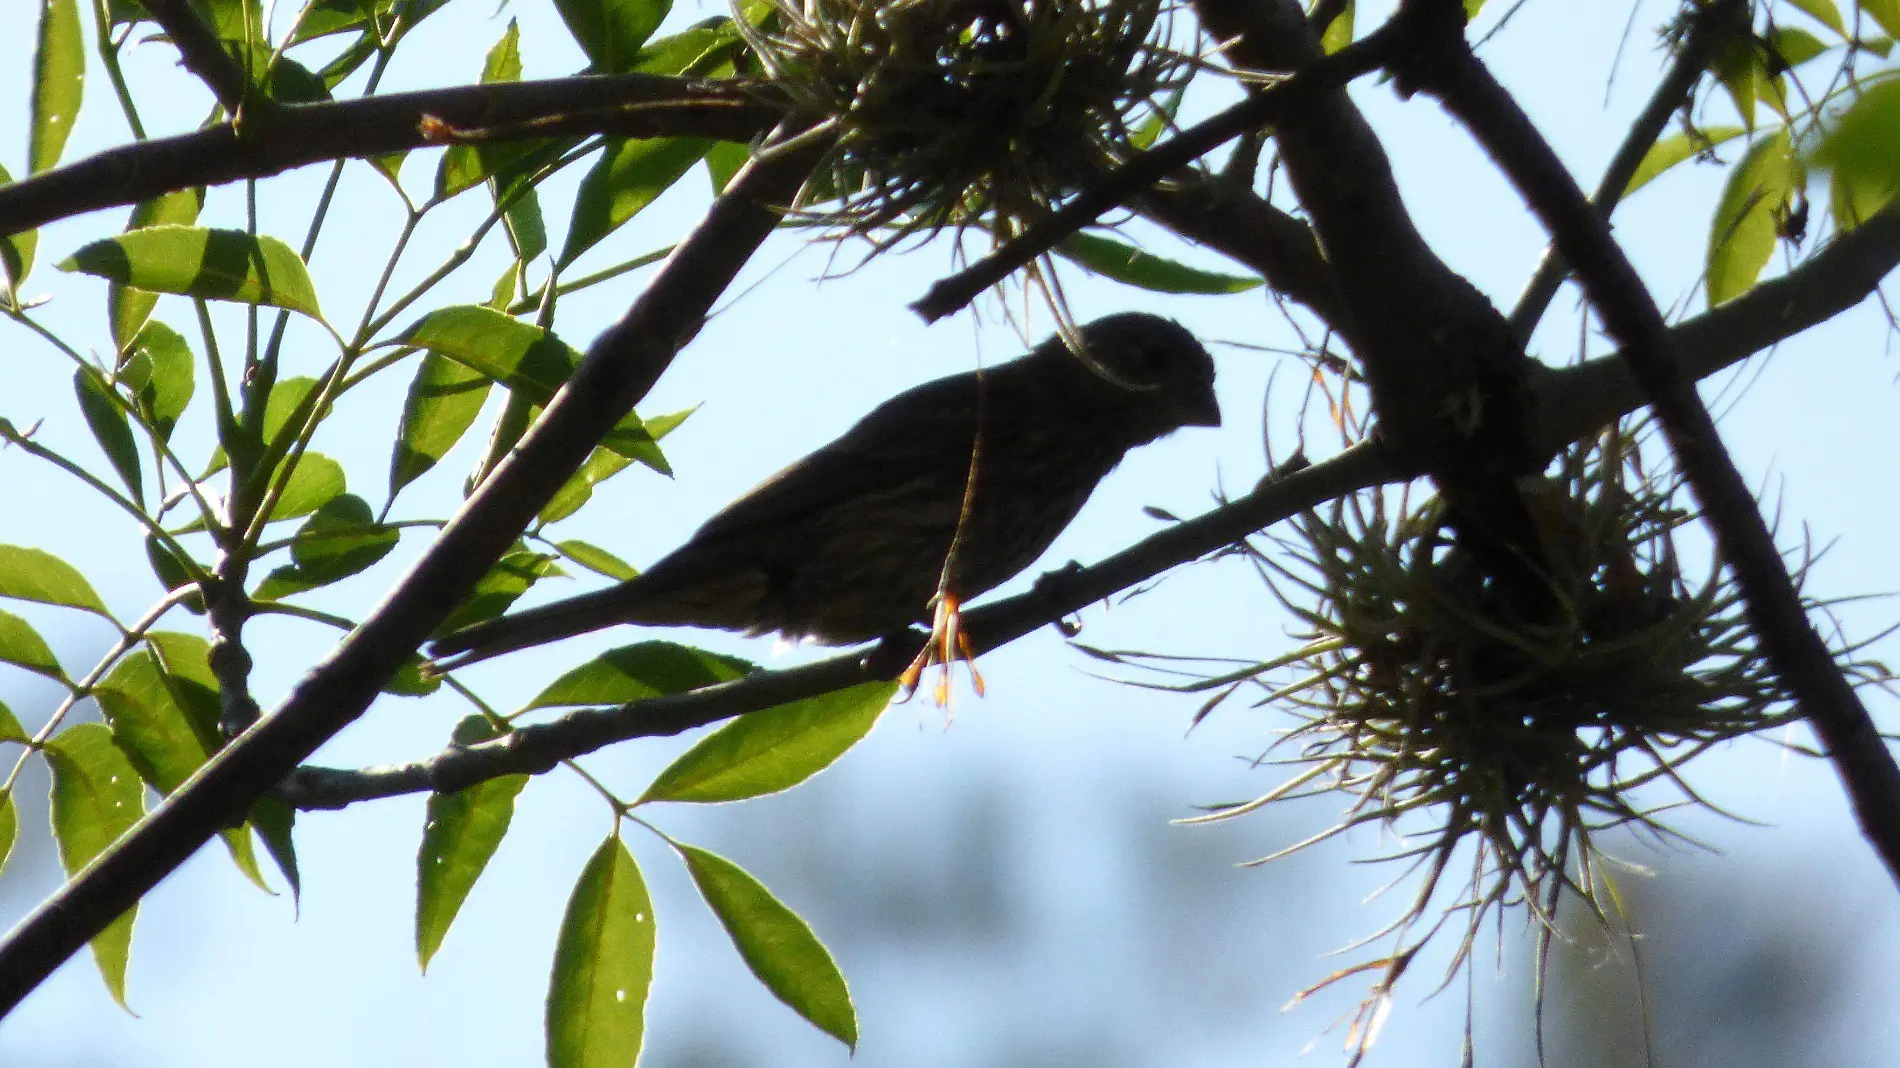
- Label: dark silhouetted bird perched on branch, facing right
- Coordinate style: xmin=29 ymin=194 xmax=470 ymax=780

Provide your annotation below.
xmin=429 ymin=312 xmax=1220 ymax=669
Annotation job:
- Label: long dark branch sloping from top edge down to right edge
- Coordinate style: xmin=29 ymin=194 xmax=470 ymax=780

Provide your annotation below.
xmin=1404 ymin=0 xmax=1900 ymax=882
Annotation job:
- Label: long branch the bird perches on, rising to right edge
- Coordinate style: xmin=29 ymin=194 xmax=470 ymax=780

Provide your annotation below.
xmin=279 ymin=195 xmax=1900 ymax=810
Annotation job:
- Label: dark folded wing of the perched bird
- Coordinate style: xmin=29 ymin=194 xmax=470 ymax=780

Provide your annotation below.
xmin=692 ymin=374 xmax=975 ymax=544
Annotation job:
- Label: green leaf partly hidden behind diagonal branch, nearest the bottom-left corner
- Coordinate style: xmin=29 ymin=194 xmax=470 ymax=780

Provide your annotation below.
xmin=46 ymin=724 xmax=144 ymax=1007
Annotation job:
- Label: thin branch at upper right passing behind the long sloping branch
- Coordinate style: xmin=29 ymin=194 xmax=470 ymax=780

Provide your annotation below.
xmin=1511 ymin=0 xmax=1748 ymax=342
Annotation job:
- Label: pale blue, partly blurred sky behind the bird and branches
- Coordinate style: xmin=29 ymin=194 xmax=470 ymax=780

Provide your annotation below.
xmin=0 ymin=0 xmax=1900 ymax=1068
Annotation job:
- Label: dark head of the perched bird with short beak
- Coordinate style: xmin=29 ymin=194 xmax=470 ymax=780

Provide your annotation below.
xmin=1053 ymin=312 xmax=1220 ymax=435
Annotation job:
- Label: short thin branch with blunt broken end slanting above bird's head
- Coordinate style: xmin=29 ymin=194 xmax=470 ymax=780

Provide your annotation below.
xmin=910 ymin=25 xmax=1402 ymax=323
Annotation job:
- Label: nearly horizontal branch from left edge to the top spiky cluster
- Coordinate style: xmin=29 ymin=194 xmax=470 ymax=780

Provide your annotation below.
xmin=0 ymin=74 xmax=783 ymax=236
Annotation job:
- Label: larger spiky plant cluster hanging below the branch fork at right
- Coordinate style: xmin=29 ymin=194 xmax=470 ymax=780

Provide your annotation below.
xmin=1113 ymin=428 xmax=1889 ymax=1049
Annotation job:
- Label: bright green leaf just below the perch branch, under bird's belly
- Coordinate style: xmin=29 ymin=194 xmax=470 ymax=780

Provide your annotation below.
xmin=637 ymin=682 xmax=897 ymax=804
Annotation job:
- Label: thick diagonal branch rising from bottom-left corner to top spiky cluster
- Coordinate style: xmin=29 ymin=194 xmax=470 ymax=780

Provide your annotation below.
xmin=0 ymin=124 xmax=813 ymax=1015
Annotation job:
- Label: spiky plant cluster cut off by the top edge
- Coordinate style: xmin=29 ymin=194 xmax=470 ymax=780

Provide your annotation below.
xmin=739 ymin=0 xmax=1186 ymax=249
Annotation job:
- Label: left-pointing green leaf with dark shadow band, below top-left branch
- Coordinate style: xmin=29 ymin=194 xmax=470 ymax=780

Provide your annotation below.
xmin=59 ymin=226 xmax=323 ymax=323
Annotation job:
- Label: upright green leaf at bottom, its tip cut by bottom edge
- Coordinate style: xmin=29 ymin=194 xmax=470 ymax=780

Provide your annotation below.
xmin=547 ymin=838 xmax=654 ymax=1068
